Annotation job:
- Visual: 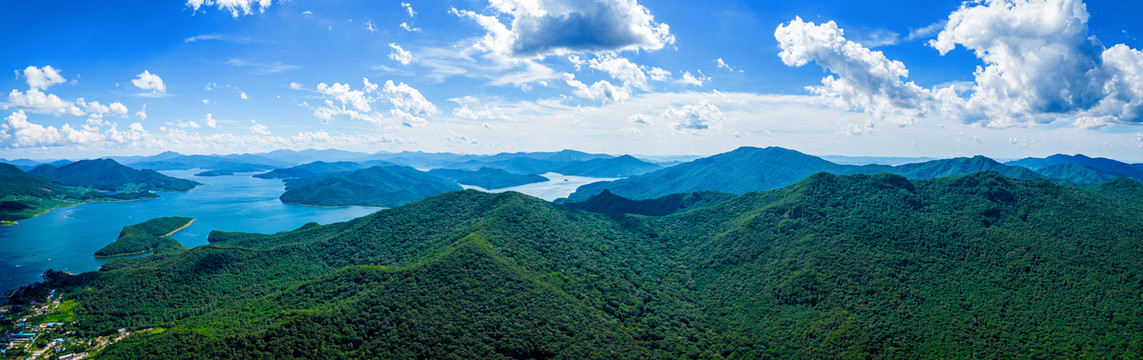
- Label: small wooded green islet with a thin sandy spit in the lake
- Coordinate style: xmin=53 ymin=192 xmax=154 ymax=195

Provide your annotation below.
xmin=95 ymin=216 xmax=194 ymax=256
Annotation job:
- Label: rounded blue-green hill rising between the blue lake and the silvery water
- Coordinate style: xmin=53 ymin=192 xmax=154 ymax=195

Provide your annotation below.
xmin=280 ymin=166 xmax=461 ymax=207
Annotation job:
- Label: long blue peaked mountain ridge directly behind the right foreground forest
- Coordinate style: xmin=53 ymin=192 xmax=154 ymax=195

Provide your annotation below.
xmin=568 ymin=146 xmax=1042 ymax=200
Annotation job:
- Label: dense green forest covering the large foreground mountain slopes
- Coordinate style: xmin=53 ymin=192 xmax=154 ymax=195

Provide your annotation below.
xmin=20 ymin=171 xmax=1143 ymax=359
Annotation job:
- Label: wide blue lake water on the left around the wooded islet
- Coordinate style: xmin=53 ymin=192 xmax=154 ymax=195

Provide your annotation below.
xmin=0 ymin=170 xmax=378 ymax=294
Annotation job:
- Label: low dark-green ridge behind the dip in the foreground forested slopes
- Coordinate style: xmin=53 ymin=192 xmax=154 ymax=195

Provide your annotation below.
xmin=561 ymin=190 xmax=737 ymax=216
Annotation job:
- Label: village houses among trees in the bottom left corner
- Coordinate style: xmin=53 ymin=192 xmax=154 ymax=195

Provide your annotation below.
xmin=0 ymin=290 xmax=138 ymax=360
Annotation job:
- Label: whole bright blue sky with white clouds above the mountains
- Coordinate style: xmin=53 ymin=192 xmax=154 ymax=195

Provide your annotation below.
xmin=0 ymin=0 xmax=1143 ymax=162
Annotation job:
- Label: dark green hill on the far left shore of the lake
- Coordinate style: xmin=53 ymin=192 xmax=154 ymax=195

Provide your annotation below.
xmin=30 ymin=159 xmax=201 ymax=192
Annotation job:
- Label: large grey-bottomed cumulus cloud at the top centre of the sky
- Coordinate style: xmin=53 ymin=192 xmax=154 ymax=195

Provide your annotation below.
xmin=453 ymin=0 xmax=674 ymax=58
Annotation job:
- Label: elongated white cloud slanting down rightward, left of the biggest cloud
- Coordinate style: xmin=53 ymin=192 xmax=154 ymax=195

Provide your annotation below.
xmin=774 ymin=17 xmax=932 ymax=126
